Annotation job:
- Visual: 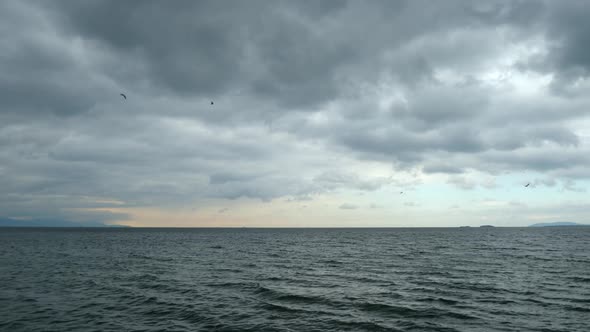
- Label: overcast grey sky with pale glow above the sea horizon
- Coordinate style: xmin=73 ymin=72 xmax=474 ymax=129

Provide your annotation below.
xmin=0 ymin=0 xmax=590 ymax=227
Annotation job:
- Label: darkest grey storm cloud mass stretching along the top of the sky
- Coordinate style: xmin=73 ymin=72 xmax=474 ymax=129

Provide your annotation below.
xmin=13 ymin=1 xmax=548 ymax=111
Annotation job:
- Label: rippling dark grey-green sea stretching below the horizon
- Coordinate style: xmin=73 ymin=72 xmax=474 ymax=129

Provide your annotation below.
xmin=0 ymin=227 xmax=590 ymax=332
